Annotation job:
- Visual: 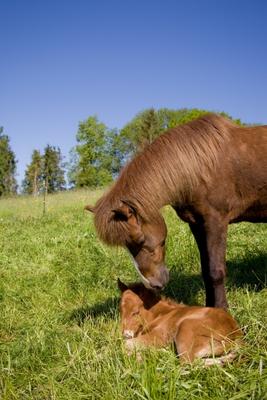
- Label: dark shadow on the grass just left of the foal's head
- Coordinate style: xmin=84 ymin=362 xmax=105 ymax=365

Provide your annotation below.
xmin=70 ymin=297 xmax=119 ymax=325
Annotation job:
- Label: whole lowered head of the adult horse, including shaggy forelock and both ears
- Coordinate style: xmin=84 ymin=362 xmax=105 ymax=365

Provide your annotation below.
xmin=85 ymin=202 xmax=169 ymax=289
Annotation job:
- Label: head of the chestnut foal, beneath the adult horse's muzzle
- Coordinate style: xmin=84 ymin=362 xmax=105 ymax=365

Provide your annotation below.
xmin=118 ymin=279 xmax=160 ymax=339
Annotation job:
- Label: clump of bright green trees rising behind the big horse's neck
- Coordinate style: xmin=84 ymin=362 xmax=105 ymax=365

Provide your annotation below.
xmin=68 ymin=108 xmax=245 ymax=187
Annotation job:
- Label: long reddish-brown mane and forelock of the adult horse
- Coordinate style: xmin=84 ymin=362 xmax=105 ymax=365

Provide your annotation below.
xmin=94 ymin=114 xmax=236 ymax=245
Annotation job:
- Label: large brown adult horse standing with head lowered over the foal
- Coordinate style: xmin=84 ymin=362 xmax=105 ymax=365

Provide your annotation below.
xmin=86 ymin=114 xmax=267 ymax=308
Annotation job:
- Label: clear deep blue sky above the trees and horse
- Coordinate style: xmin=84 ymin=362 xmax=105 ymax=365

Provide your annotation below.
xmin=0 ymin=0 xmax=267 ymax=183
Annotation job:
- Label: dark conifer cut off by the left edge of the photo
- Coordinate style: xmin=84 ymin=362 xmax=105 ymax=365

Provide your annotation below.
xmin=0 ymin=127 xmax=17 ymax=197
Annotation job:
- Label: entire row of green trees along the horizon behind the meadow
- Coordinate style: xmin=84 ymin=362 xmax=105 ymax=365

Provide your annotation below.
xmin=0 ymin=108 xmax=244 ymax=197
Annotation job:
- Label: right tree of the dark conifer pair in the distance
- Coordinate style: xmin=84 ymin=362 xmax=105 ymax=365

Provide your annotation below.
xmin=42 ymin=144 xmax=66 ymax=193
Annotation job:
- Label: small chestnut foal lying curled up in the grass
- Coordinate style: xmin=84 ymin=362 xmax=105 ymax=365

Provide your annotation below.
xmin=118 ymin=280 xmax=242 ymax=366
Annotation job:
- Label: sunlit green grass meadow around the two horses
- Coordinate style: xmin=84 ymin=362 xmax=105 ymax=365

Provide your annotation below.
xmin=0 ymin=191 xmax=267 ymax=400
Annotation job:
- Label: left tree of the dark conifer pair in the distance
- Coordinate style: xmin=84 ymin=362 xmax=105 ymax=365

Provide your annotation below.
xmin=22 ymin=150 xmax=43 ymax=196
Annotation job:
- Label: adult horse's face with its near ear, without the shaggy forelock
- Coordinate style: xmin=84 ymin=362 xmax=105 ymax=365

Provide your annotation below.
xmin=113 ymin=202 xmax=169 ymax=289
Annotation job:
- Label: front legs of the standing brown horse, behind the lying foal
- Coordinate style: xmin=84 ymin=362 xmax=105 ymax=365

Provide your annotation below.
xmin=190 ymin=218 xmax=228 ymax=309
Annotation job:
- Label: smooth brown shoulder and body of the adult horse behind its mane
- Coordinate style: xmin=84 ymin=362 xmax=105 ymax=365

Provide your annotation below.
xmin=180 ymin=126 xmax=267 ymax=223
